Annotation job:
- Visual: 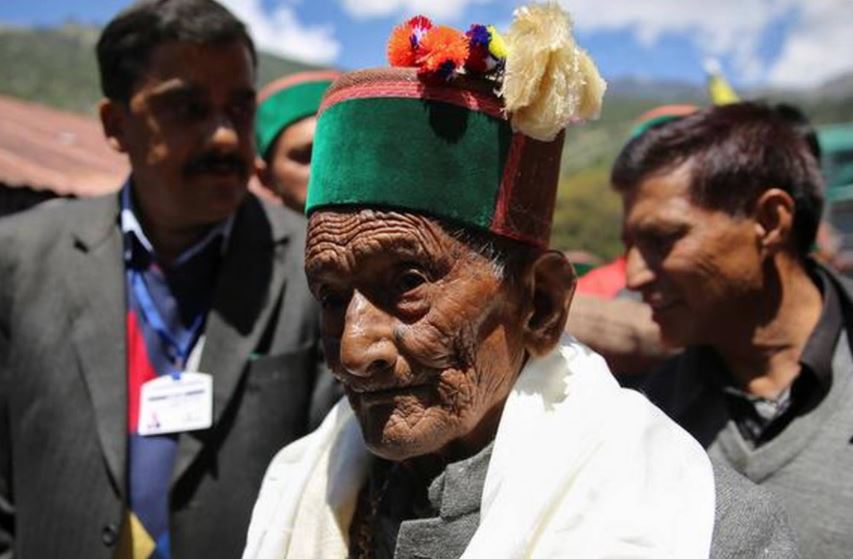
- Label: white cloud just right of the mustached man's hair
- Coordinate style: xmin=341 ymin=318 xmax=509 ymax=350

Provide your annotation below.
xmin=221 ymin=0 xmax=341 ymax=64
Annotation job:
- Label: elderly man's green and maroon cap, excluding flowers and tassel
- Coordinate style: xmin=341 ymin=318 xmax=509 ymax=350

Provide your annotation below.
xmin=306 ymin=68 xmax=564 ymax=244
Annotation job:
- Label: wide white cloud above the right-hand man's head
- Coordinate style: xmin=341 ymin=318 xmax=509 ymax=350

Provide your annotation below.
xmin=561 ymin=0 xmax=853 ymax=87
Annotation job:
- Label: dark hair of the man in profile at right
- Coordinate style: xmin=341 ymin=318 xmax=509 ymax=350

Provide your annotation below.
xmin=611 ymin=102 xmax=823 ymax=256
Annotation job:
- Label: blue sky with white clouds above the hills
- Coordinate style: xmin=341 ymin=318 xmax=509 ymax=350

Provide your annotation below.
xmin=0 ymin=0 xmax=853 ymax=87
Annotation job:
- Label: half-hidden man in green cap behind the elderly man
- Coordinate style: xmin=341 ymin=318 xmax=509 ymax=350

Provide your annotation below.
xmin=255 ymin=70 xmax=340 ymax=213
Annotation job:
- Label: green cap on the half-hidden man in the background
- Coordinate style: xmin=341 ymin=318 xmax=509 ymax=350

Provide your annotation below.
xmin=255 ymin=70 xmax=340 ymax=157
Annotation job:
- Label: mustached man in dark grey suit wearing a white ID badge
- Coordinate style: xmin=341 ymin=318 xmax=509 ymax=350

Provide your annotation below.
xmin=0 ymin=0 xmax=336 ymax=559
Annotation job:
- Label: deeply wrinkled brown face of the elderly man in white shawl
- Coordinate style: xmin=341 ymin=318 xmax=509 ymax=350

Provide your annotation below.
xmin=305 ymin=210 xmax=525 ymax=460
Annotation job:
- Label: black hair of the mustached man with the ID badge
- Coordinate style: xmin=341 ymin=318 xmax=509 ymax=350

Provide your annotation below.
xmin=96 ymin=0 xmax=257 ymax=103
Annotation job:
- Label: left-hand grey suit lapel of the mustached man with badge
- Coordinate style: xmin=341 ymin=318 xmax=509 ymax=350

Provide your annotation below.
xmin=65 ymin=196 xmax=127 ymax=495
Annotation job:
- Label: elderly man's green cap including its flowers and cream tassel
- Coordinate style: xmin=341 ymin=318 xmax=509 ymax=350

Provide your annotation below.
xmin=306 ymin=4 xmax=604 ymax=247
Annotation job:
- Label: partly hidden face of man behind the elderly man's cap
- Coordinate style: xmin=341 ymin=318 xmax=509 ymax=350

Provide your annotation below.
xmin=269 ymin=116 xmax=317 ymax=213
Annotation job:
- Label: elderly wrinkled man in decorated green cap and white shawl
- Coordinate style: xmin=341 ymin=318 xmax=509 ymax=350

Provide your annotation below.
xmin=244 ymin=5 xmax=795 ymax=559
